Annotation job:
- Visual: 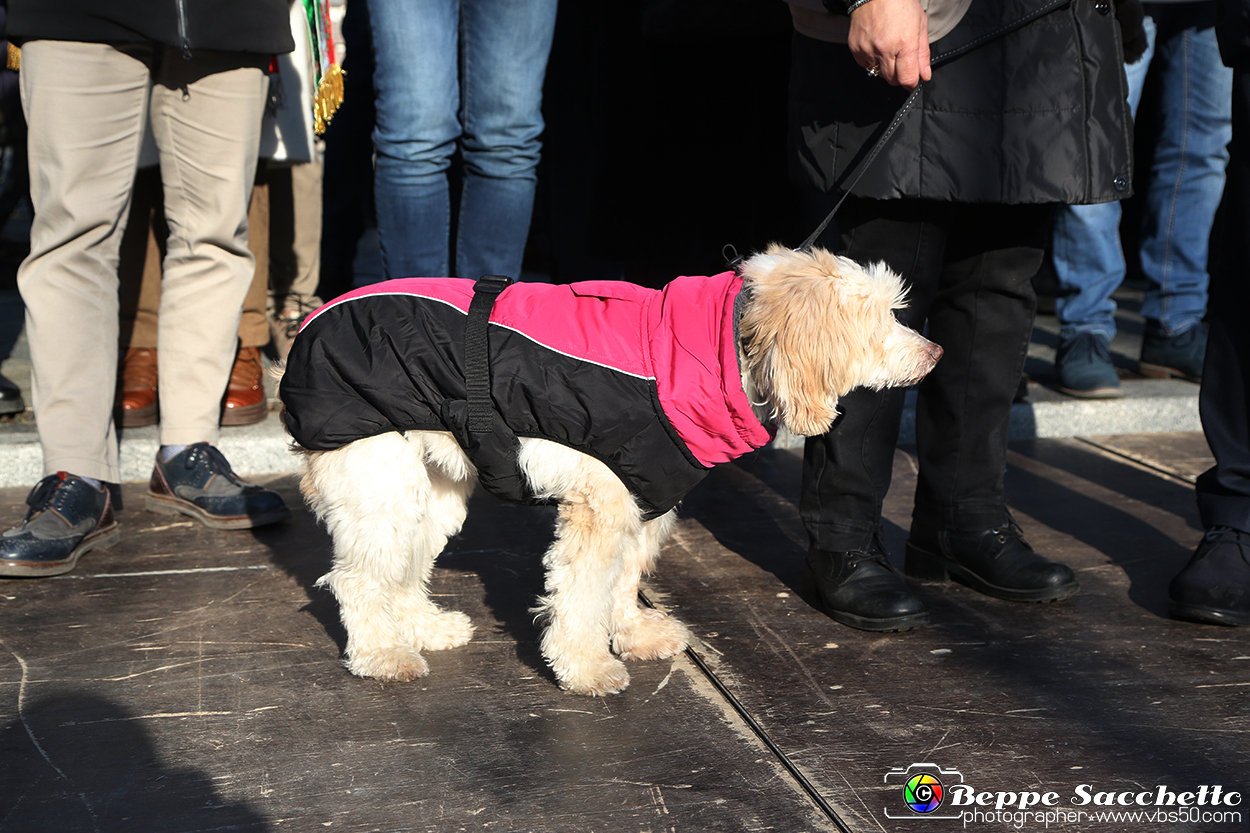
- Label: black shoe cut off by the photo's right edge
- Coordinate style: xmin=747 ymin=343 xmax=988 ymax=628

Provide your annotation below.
xmin=1168 ymin=527 xmax=1250 ymax=625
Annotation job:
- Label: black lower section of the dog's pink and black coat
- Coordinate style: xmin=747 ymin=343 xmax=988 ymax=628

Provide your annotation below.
xmin=281 ymin=288 xmax=708 ymax=518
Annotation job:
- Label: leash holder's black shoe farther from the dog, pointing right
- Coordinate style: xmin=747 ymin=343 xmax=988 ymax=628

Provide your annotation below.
xmin=904 ymin=520 xmax=1080 ymax=602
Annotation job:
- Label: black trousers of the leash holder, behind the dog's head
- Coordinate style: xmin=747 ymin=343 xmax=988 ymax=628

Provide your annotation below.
xmin=800 ymin=198 xmax=1053 ymax=550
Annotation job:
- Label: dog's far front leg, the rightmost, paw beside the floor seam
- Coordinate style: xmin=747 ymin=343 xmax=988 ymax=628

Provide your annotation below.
xmin=611 ymin=512 xmax=690 ymax=659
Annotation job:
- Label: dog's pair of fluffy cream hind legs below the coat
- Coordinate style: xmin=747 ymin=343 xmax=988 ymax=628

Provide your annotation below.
xmin=301 ymin=432 xmax=473 ymax=680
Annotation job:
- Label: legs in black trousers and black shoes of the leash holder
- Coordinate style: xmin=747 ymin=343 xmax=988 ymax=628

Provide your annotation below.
xmin=800 ymin=199 xmax=1076 ymax=630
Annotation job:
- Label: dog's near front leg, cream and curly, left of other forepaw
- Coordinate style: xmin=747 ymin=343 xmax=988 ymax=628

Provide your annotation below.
xmin=521 ymin=440 xmax=643 ymax=697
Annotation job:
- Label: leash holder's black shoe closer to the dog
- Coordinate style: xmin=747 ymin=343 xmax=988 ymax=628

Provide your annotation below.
xmin=804 ymin=540 xmax=929 ymax=633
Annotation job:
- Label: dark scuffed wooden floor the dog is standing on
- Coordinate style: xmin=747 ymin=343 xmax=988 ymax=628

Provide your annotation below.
xmin=0 ymin=434 xmax=1250 ymax=833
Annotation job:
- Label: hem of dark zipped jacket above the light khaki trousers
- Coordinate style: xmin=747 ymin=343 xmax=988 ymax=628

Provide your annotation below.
xmin=9 ymin=0 xmax=295 ymax=55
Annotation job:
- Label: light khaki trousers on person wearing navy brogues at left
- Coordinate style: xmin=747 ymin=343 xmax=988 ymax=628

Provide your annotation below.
xmin=18 ymin=40 xmax=269 ymax=482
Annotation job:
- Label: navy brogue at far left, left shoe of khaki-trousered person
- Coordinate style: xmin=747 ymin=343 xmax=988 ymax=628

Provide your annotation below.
xmin=0 ymin=472 xmax=121 ymax=578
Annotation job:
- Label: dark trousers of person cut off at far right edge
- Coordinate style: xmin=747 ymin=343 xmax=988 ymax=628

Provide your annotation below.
xmin=1196 ymin=68 xmax=1250 ymax=532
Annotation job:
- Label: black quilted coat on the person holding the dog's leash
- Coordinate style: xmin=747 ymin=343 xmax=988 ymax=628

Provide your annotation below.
xmin=790 ymin=0 xmax=1133 ymax=205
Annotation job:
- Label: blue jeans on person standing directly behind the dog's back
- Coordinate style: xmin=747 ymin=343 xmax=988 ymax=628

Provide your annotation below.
xmin=369 ymin=0 xmax=556 ymax=278
